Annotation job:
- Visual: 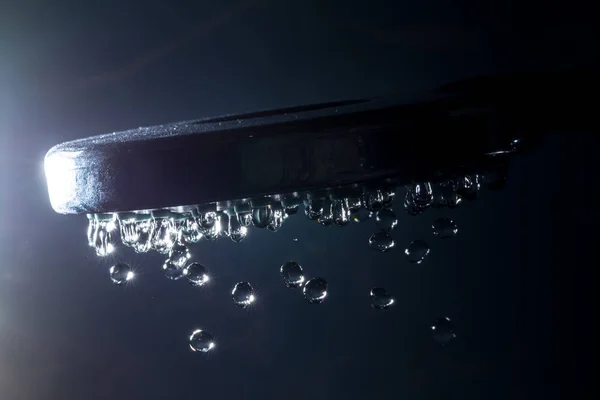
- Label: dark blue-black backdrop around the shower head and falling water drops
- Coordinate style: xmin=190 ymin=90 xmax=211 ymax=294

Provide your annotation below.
xmin=0 ymin=0 xmax=598 ymax=400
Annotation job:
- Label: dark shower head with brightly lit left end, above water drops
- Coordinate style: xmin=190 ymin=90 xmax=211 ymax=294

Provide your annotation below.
xmin=46 ymin=69 xmax=597 ymax=214
